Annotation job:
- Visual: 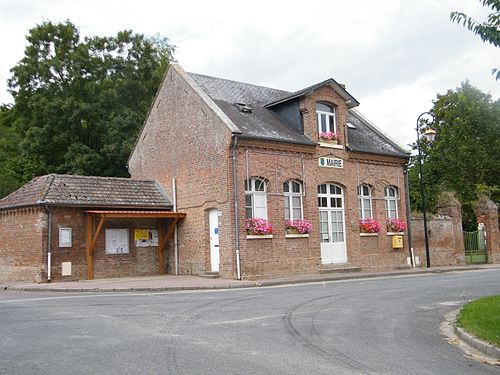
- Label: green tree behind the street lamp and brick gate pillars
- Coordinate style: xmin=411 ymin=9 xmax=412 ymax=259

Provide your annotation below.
xmin=410 ymin=82 xmax=500 ymax=230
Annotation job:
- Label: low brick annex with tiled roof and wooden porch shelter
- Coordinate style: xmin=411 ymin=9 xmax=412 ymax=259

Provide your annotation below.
xmin=0 ymin=175 xmax=185 ymax=282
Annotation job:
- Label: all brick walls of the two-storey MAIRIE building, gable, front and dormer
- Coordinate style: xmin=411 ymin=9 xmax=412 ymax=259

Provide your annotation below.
xmin=129 ymin=69 xmax=407 ymax=277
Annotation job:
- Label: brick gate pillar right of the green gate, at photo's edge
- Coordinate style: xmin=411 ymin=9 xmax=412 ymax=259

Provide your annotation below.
xmin=474 ymin=195 xmax=500 ymax=263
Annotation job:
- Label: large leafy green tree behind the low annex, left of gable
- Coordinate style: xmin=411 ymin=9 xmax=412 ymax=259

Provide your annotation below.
xmin=0 ymin=21 xmax=174 ymax=196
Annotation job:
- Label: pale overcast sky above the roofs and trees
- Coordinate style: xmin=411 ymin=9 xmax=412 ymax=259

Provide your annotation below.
xmin=0 ymin=0 xmax=500 ymax=150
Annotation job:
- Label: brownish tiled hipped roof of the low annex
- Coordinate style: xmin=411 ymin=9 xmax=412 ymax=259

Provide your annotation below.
xmin=0 ymin=174 xmax=172 ymax=210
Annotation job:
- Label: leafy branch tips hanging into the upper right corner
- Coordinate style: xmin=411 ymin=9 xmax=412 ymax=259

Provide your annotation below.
xmin=450 ymin=0 xmax=500 ymax=80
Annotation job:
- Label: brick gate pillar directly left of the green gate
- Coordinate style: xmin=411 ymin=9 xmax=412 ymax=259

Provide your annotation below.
xmin=437 ymin=192 xmax=465 ymax=264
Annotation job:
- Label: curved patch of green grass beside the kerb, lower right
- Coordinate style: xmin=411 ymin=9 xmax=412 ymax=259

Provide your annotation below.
xmin=458 ymin=296 xmax=500 ymax=347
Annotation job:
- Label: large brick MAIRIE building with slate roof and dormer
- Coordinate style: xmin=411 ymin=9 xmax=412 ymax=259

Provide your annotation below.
xmin=128 ymin=64 xmax=408 ymax=278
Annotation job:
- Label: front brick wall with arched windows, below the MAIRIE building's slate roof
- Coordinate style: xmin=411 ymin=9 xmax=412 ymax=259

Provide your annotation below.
xmin=234 ymin=138 xmax=408 ymax=277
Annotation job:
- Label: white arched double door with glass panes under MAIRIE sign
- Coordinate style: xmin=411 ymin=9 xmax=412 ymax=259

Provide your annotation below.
xmin=318 ymin=184 xmax=347 ymax=264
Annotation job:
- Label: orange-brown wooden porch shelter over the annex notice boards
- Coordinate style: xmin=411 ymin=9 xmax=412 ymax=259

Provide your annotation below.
xmin=84 ymin=210 xmax=186 ymax=280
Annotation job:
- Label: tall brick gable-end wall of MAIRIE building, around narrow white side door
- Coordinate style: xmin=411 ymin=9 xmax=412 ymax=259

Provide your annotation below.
xmin=129 ymin=64 xmax=235 ymax=277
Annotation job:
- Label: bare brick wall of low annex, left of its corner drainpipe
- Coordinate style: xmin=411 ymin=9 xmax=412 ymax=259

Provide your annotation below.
xmin=0 ymin=208 xmax=47 ymax=282
